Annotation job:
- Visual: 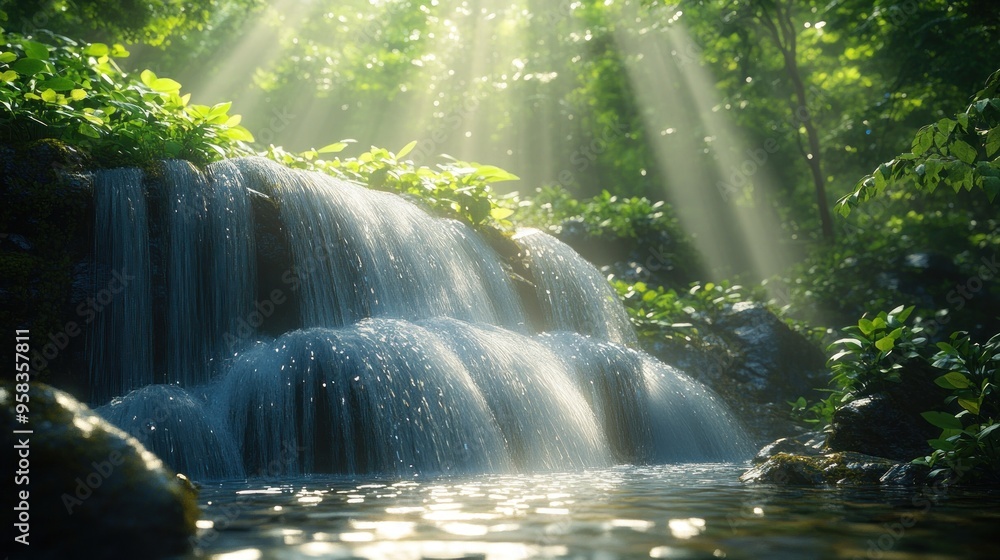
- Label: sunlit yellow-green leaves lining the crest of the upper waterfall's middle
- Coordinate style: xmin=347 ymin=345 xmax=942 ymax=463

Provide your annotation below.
xmin=265 ymin=140 xmax=518 ymax=229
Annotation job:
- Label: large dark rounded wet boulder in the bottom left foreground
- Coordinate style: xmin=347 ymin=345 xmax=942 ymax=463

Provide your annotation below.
xmin=0 ymin=382 xmax=199 ymax=558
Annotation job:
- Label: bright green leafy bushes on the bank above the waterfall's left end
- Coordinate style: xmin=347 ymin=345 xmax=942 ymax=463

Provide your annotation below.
xmin=0 ymin=29 xmax=253 ymax=166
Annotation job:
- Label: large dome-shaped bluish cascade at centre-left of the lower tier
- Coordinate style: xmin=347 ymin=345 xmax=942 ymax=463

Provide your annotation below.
xmin=220 ymin=319 xmax=510 ymax=474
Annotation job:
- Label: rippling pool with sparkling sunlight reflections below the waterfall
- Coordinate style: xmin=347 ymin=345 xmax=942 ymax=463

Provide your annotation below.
xmin=188 ymin=464 xmax=1000 ymax=560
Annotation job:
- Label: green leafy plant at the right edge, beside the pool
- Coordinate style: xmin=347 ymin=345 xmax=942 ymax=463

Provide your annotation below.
xmin=915 ymin=331 xmax=1000 ymax=478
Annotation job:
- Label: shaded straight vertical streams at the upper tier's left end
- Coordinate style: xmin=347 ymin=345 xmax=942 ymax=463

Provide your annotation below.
xmin=87 ymin=160 xmax=256 ymax=403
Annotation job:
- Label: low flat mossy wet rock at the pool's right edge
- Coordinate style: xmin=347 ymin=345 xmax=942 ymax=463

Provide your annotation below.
xmin=740 ymin=453 xmax=898 ymax=486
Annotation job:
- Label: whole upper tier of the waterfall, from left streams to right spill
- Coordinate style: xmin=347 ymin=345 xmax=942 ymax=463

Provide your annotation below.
xmin=90 ymin=158 xmax=635 ymax=404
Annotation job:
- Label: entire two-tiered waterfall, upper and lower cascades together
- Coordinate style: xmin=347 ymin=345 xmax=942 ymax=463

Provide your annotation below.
xmin=91 ymin=158 xmax=748 ymax=478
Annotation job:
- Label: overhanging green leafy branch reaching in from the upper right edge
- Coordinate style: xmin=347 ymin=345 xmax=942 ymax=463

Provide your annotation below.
xmin=837 ymin=66 xmax=1000 ymax=216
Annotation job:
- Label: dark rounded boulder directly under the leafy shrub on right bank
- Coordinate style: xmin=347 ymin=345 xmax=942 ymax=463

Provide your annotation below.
xmin=827 ymin=394 xmax=939 ymax=461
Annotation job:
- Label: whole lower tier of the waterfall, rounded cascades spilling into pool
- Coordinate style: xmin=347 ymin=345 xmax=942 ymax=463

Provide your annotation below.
xmin=102 ymin=318 xmax=750 ymax=478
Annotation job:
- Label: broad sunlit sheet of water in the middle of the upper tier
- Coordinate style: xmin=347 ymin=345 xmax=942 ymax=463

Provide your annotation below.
xmin=224 ymin=158 xmax=525 ymax=329
